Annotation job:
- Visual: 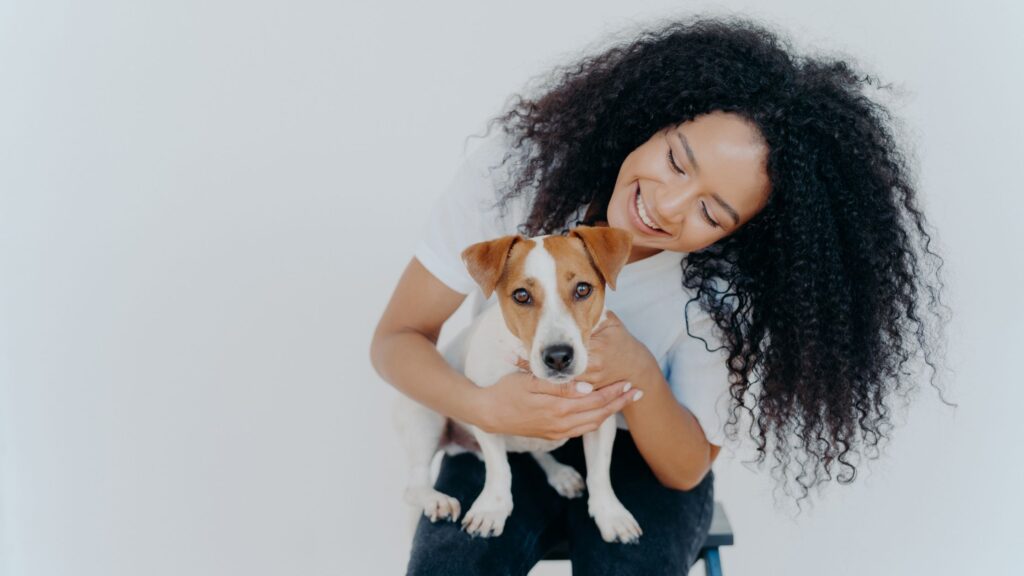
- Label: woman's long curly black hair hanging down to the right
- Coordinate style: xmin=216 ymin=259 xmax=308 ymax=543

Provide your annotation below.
xmin=477 ymin=17 xmax=948 ymax=504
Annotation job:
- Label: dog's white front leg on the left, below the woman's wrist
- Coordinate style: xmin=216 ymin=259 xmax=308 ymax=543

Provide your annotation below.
xmin=462 ymin=426 xmax=512 ymax=537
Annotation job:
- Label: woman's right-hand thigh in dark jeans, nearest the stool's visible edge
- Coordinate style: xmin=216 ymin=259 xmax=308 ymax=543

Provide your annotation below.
xmin=567 ymin=430 xmax=715 ymax=576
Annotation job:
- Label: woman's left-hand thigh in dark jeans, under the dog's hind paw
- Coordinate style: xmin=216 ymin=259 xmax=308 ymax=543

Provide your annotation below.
xmin=408 ymin=453 xmax=566 ymax=576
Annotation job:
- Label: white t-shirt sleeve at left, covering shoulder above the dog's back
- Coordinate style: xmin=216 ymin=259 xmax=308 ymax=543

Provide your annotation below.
xmin=414 ymin=131 xmax=526 ymax=294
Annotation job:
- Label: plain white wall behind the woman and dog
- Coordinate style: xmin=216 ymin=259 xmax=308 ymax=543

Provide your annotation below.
xmin=0 ymin=0 xmax=1024 ymax=576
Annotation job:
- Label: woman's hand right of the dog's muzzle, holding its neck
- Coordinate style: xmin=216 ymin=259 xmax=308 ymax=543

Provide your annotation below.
xmin=575 ymin=311 xmax=662 ymax=389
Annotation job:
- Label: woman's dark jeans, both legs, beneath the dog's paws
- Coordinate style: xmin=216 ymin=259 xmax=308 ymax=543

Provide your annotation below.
xmin=408 ymin=429 xmax=715 ymax=576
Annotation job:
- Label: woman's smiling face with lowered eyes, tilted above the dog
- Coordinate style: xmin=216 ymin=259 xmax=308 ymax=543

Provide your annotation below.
xmin=607 ymin=112 xmax=770 ymax=261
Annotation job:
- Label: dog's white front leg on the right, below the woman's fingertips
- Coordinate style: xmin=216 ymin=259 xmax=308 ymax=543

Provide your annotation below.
xmin=583 ymin=415 xmax=643 ymax=542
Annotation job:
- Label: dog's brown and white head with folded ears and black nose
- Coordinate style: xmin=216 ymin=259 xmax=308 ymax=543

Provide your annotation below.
xmin=462 ymin=227 xmax=632 ymax=382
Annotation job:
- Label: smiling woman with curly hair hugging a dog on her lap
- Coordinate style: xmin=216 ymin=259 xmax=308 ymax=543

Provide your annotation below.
xmin=372 ymin=13 xmax=943 ymax=574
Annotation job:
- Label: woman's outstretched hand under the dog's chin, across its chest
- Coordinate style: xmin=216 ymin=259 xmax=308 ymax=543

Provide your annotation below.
xmin=474 ymin=372 xmax=633 ymax=440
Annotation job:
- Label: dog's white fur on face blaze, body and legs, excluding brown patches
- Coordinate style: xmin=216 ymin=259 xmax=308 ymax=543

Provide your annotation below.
xmin=395 ymin=237 xmax=642 ymax=542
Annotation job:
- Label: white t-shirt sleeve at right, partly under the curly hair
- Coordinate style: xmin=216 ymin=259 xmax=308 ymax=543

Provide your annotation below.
xmin=666 ymin=301 xmax=730 ymax=446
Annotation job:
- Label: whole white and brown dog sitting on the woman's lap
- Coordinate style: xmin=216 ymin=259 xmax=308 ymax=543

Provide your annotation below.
xmin=395 ymin=227 xmax=641 ymax=542
